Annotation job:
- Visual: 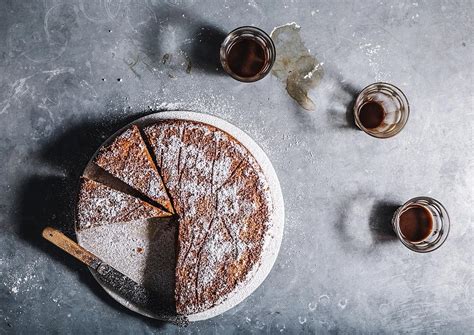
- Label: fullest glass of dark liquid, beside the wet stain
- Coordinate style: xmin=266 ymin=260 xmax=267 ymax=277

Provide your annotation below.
xmin=220 ymin=26 xmax=276 ymax=82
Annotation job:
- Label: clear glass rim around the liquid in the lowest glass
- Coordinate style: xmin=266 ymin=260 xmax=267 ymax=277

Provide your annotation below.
xmin=392 ymin=196 xmax=451 ymax=253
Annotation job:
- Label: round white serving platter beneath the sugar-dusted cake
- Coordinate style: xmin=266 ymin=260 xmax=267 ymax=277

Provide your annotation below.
xmin=76 ymin=111 xmax=285 ymax=321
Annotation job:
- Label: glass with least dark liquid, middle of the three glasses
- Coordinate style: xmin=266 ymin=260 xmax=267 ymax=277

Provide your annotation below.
xmin=354 ymin=83 xmax=410 ymax=138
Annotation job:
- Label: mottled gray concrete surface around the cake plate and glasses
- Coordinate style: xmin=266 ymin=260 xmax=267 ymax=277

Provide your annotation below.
xmin=0 ymin=0 xmax=474 ymax=334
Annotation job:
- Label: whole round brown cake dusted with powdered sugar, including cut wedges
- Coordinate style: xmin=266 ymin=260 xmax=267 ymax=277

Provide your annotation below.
xmin=76 ymin=120 xmax=274 ymax=315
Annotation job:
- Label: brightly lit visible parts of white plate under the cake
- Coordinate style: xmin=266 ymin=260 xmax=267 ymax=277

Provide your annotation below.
xmin=76 ymin=111 xmax=285 ymax=321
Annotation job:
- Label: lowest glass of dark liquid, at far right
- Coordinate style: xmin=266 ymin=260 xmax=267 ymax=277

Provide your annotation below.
xmin=392 ymin=197 xmax=451 ymax=252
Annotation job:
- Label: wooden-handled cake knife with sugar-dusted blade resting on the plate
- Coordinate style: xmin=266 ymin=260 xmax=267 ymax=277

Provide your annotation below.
xmin=42 ymin=227 xmax=188 ymax=326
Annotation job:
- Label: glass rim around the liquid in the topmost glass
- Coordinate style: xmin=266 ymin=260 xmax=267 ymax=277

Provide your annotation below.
xmin=219 ymin=26 xmax=276 ymax=83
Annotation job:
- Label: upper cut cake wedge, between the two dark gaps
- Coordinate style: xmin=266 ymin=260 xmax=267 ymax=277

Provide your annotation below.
xmin=94 ymin=125 xmax=174 ymax=213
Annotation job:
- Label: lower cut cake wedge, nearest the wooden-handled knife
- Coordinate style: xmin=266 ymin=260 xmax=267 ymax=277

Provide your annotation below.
xmin=77 ymin=177 xmax=171 ymax=229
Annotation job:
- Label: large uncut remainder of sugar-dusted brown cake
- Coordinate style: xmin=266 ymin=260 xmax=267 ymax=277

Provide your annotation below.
xmin=144 ymin=120 xmax=272 ymax=315
